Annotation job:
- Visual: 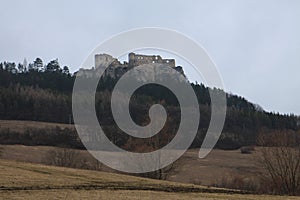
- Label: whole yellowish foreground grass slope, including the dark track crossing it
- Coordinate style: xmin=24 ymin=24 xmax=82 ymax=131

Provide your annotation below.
xmin=0 ymin=160 xmax=300 ymax=200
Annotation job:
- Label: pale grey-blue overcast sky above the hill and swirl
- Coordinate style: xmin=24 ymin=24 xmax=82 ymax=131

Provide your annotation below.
xmin=0 ymin=0 xmax=300 ymax=114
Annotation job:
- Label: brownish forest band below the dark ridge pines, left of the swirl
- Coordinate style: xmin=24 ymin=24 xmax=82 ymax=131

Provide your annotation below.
xmin=0 ymin=84 xmax=72 ymax=123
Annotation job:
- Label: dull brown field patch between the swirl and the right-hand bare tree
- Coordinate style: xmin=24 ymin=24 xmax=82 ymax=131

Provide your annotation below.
xmin=168 ymin=149 xmax=262 ymax=185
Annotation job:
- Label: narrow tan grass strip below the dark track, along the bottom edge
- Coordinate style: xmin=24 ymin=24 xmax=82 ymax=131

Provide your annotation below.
xmin=0 ymin=190 xmax=299 ymax=200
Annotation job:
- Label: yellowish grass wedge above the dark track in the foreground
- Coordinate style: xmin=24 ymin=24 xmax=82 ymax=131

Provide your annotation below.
xmin=0 ymin=160 xmax=232 ymax=192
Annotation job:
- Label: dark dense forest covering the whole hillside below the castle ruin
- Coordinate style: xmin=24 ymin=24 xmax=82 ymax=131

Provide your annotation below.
xmin=0 ymin=58 xmax=299 ymax=151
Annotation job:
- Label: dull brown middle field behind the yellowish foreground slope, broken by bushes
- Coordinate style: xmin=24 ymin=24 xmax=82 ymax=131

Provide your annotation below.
xmin=0 ymin=145 xmax=261 ymax=186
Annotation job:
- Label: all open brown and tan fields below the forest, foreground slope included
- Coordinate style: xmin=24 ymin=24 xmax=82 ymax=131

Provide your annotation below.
xmin=0 ymin=120 xmax=300 ymax=200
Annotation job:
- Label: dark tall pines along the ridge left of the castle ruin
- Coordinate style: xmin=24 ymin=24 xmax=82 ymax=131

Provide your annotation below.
xmin=0 ymin=58 xmax=75 ymax=93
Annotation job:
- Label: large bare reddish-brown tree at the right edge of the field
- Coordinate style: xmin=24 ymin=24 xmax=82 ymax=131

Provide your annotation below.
xmin=258 ymin=131 xmax=300 ymax=195
